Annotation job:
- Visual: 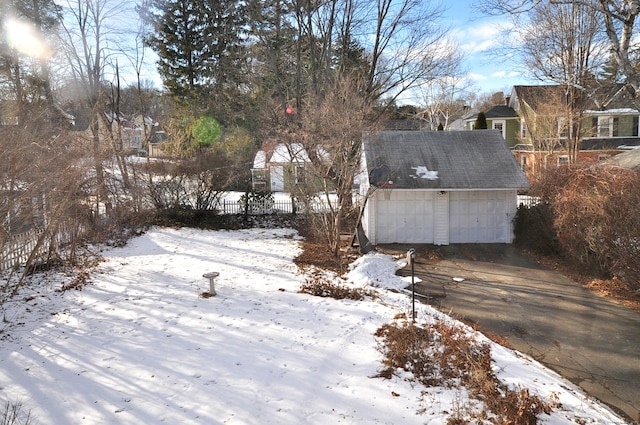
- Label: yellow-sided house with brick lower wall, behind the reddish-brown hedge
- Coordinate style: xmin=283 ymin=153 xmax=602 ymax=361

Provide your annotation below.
xmin=509 ymin=85 xmax=640 ymax=177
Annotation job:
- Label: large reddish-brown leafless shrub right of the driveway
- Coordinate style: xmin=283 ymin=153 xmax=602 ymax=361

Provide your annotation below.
xmin=535 ymin=167 xmax=640 ymax=288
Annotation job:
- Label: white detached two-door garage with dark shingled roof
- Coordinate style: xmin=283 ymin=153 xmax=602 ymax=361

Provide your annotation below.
xmin=361 ymin=130 xmax=529 ymax=245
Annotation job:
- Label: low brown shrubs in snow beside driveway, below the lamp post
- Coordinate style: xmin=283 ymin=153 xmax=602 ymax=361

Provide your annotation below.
xmin=376 ymin=317 xmax=552 ymax=425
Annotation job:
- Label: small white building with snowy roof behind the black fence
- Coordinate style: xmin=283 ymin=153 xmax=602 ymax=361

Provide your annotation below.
xmin=251 ymin=143 xmax=326 ymax=192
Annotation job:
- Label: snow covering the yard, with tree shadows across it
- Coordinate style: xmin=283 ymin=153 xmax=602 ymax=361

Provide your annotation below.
xmin=0 ymin=228 xmax=624 ymax=424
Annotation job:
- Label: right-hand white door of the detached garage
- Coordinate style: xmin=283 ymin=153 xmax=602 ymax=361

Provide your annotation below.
xmin=449 ymin=191 xmax=513 ymax=243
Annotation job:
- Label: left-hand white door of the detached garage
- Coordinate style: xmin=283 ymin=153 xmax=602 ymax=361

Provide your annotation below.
xmin=375 ymin=190 xmax=434 ymax=243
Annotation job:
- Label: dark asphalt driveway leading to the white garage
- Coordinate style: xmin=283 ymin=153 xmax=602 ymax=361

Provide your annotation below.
xmin=377 ymin=244 xmax=640 ymax=424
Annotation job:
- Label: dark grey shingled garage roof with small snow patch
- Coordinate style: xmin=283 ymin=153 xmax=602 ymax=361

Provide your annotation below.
xmin=364 ymin=130 xmax=529 ymax=189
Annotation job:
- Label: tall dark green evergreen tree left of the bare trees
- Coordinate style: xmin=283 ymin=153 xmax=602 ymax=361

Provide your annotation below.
xmin=138 ymin=0 xmax=246 ymax=114
